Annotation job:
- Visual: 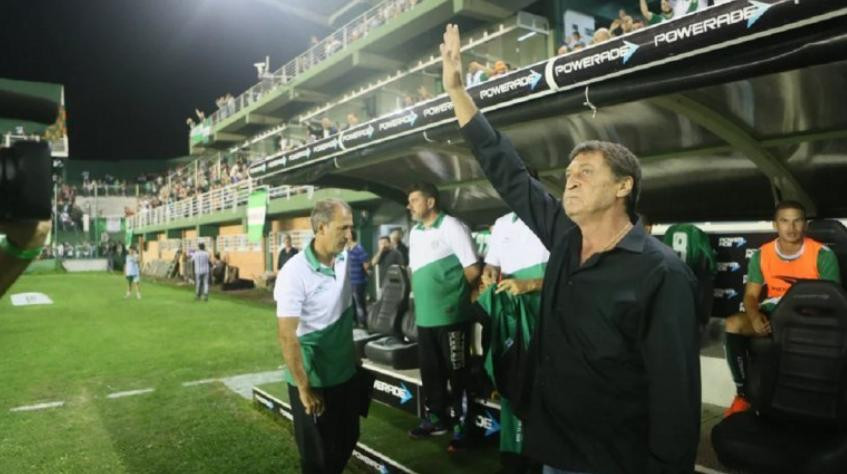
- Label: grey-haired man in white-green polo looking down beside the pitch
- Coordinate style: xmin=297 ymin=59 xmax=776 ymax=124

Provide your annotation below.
xmin=274 ymin=199 xmax=359 ymax=473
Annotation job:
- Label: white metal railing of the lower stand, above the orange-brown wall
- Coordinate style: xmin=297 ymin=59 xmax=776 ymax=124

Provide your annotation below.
xmin=127 ymin=180 xmax=315 ymax=229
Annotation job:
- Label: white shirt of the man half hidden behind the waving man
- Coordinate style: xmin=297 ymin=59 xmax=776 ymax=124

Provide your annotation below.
xmin=485 ymin=212 xmax=550 ymax=280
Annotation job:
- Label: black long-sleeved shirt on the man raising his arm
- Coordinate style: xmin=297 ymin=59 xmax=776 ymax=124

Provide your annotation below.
xmin=462 ymin=113 xmax=700 ymax=474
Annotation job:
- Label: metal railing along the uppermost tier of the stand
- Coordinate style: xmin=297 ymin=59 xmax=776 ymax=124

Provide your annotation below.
xmin=192 ymin=0 xmax=420 ymax=132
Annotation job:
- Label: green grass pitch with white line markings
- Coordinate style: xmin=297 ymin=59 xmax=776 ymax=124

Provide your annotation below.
xmin=0 ymin=273 xmax=362 ymax=473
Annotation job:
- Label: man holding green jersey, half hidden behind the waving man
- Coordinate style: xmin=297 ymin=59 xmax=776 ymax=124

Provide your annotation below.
xmin=477 ymin=212 xmax=550 ymax=472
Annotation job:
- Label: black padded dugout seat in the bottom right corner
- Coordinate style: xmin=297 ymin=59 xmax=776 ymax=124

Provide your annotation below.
xmin=712 ymin=280 xmax=847 ymax=474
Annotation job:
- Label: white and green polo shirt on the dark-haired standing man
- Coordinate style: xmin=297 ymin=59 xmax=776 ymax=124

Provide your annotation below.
xmin=409 ymin=212 xmax=476 ymax=327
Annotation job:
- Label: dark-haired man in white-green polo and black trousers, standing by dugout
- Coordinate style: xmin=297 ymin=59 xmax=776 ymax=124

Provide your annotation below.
xmin=407 ymin=183 xmax=480 ymax=452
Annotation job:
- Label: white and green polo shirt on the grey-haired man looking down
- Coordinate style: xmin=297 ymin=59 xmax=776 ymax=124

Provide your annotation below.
xmin=274 ymin=242 xmax=356 ymax=387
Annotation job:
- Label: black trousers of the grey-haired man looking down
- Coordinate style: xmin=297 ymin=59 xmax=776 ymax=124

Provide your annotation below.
xmin=288 ymin=377 xmax=361 ymax=474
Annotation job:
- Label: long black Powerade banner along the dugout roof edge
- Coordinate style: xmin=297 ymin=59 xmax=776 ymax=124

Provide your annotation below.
xmin=249 ymin=0 xmax=847 ymax=178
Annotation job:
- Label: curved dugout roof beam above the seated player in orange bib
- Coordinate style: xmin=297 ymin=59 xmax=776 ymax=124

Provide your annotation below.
xmin=649 ymin=94 xmax=817 ymax=216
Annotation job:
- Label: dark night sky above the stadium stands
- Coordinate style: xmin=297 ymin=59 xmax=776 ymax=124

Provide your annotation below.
xmin=0 ymin=0 xmax=327 ymax=160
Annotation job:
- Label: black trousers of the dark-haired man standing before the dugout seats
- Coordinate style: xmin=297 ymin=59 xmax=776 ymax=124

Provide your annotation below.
xmin=418 ymin=321 xmax=472 ymax=420
